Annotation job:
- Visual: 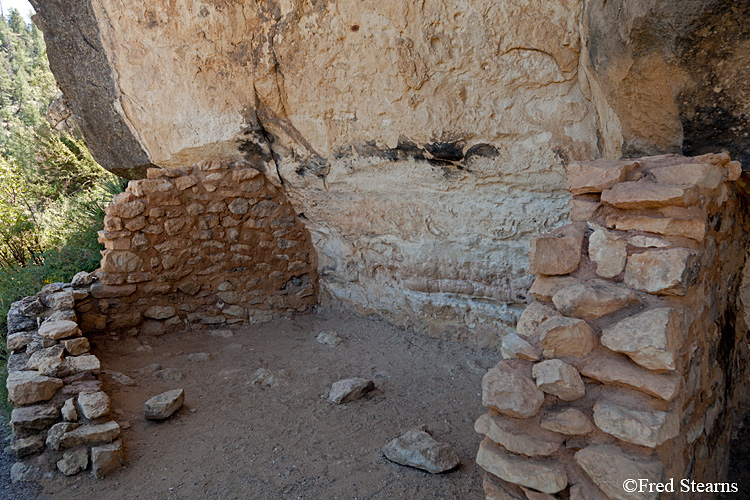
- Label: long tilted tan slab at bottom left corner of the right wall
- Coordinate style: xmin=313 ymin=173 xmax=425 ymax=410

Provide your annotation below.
xmin=477 ymin=438 xmax=568 ymax=494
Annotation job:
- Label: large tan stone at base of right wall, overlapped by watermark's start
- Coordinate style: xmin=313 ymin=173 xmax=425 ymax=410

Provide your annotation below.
xmin=575 ymin=444 xmax=664 ymax=500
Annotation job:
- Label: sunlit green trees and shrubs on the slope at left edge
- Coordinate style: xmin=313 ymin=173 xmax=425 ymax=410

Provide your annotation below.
xmin=0 ymin=9 xmax=126 ymax=414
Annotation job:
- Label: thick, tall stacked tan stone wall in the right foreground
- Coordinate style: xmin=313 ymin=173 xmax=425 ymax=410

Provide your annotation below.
xmin=476 ymin=154 xmax=750 ymax=500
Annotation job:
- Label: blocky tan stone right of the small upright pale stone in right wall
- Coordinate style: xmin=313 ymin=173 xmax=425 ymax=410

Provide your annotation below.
xmin=625 ymin=248 xmax=701 ymax=295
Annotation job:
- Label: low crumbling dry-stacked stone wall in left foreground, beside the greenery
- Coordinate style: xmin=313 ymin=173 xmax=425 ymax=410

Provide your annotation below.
xmin=7 ymin=273 xmax=123 ymax=481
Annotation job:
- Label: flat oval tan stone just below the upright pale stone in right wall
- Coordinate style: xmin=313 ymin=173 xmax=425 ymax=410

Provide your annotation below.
xmin=552 ymin=282 xmax=638 ymax=319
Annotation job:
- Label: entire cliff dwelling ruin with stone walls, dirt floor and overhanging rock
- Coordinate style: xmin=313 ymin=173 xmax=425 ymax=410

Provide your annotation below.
xmin=8 ymin=0 xmax=750 ymax=500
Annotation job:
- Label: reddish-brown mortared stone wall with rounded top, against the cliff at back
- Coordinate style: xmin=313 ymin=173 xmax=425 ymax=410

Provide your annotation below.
xmin=77 ymin=162 xmax=317 ymax=335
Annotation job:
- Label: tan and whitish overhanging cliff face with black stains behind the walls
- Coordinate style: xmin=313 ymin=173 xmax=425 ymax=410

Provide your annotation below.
xmin=32 ymin=0 xmax=741 ymax=344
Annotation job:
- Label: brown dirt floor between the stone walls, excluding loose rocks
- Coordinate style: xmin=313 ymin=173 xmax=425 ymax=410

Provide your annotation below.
xmin=13 ymin=313 xmax=498 ymax=500
